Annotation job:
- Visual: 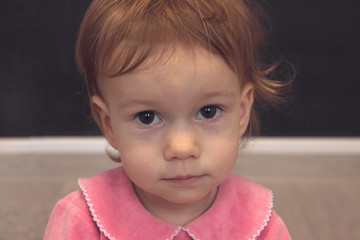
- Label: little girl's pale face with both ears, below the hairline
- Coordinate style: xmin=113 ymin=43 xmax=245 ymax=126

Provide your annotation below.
xmin=92 ymin=48 xmax=253 ymax=215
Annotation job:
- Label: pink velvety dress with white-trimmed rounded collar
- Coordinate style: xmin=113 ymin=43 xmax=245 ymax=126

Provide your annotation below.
xmin=44 ymin=167 xmax=291 ymax=240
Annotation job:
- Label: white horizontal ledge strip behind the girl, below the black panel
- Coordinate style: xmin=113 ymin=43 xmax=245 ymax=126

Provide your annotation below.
xmin=0 ymin=137 xmax=360 ymax=156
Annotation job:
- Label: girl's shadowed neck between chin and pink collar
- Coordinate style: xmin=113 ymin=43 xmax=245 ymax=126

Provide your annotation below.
xmin=134 ymin=185 xmax=217 ymax=226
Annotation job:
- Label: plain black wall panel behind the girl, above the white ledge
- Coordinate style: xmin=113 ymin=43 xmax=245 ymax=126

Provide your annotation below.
xmin=0 ymin=0 xmax=360 ymax=137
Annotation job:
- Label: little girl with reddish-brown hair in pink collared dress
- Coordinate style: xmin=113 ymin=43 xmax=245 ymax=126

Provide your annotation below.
xmin=45 ymin=0 xmax=290 ymax=240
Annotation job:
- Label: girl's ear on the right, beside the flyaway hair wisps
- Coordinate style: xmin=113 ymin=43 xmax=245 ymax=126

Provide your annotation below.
xmin=240 ymin=83 xmax=254 ymax=137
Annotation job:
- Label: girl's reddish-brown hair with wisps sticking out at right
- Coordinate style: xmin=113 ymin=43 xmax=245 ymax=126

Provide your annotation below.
xmin=76 ymin=0 xmax=291 ymax=142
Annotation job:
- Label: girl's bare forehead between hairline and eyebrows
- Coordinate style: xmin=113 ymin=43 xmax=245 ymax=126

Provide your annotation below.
xmin=104 ymin=51 xmax=240 ymax=107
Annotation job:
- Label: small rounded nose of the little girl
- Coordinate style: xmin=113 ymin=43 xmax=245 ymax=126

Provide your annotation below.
xmin=164 ymin=125 xmax=200 ymax=161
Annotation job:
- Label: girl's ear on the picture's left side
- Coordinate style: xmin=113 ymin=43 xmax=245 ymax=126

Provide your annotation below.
xmin=91 ymin=95 xmax=117 ymax=149
